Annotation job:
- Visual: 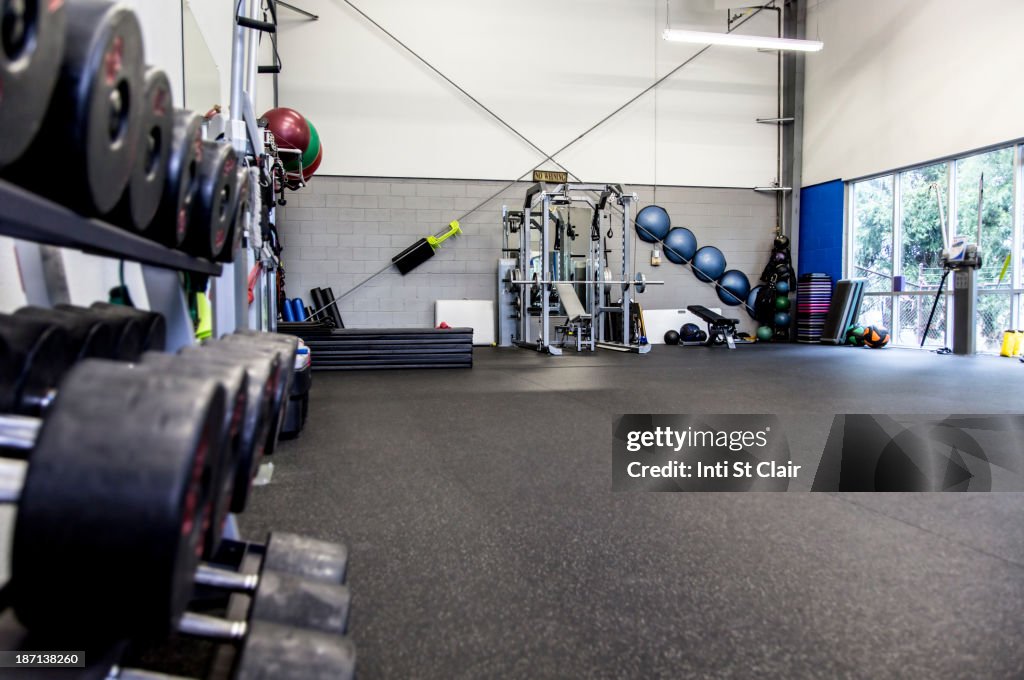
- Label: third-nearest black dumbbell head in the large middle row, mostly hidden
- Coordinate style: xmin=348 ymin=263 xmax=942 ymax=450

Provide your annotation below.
xmin=181 ymin=345 xmax=280 ymax=512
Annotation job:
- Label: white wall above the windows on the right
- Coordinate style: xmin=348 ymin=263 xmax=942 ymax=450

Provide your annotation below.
xmin=803 ymin=0 xmax=1024 ymax=185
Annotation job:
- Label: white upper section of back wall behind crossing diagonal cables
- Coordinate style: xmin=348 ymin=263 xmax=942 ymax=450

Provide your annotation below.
xmin=267 ymin=0 xmax=776 ymax=186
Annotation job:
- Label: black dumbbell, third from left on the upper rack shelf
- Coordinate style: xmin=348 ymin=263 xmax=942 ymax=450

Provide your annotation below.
xmin=109 ymin=67 xmax=174 ymax=232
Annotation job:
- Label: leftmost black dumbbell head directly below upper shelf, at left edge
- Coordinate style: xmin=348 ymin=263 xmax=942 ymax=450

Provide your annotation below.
xmin=0 ymin=314 xmax=78 ymax=415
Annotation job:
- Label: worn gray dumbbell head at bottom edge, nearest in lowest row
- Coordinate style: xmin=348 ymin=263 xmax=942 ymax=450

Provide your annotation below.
xmin=232 ymin=621 xmax=355 ymax=680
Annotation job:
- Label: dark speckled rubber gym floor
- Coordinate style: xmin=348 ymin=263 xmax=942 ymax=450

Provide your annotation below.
xmin=237 ymin=345 xmax=1024 ymax=680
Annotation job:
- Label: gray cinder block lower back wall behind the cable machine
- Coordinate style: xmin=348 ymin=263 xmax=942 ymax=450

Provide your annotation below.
xmin=278 ymin=177 xmax=775 ymax=330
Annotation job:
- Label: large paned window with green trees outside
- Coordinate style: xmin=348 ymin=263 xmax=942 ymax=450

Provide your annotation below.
xmin=847 ymin=145 xmax=1024 ymax=352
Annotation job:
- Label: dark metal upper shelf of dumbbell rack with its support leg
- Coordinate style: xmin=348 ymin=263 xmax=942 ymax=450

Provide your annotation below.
xmin=0 ymin=179 xmax=222 ymax=349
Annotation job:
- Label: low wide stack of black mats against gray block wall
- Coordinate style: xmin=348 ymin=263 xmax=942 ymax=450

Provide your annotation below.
xmin=278 ymin=322 xmax=473 ymax=371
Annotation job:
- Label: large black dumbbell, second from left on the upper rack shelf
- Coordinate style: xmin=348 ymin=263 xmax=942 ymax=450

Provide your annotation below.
xmin=9 ymin=0 xmax=142 ymax=215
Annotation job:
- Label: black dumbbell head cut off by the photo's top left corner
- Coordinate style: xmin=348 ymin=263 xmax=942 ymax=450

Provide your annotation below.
xmin=0 ymin=0 xmax=67 ymax=168
